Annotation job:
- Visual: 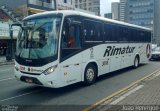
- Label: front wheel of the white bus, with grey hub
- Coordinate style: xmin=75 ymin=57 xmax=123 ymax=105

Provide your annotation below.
xmin=84 ymin=64 xmax=97 ymax=85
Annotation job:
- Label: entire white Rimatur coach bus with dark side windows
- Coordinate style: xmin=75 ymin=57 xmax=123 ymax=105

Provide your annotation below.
xmin=15 ymin=11 xmax=151 ymax=88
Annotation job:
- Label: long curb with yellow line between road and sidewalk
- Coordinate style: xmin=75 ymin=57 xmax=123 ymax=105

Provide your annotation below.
xmin=82 ymin=69 xmax=160 ymax=111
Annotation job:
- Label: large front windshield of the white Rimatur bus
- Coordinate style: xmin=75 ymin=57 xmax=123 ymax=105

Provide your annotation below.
xmin=16 ymin=16 xmax=61 ymax=59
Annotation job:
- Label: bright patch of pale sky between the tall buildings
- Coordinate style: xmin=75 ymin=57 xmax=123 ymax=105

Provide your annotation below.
xmin=100 ymin=0 xmax=119 ymax=15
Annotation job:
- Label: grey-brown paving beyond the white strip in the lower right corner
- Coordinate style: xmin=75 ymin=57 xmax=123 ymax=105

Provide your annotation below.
xmin=117 ymin=76 xmax=160 ymax=106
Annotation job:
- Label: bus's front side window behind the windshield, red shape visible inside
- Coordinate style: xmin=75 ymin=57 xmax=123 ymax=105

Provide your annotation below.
xmin=61 ymin=21 xmax=81 ymax=61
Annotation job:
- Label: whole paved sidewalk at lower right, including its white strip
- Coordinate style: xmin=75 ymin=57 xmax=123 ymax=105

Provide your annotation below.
xmin=87 ymin=70 xmax=160 ymax=111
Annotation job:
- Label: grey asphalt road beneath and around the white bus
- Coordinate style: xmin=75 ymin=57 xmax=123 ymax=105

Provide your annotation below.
xmin=0 ymin=61 xmax=160 ymax=109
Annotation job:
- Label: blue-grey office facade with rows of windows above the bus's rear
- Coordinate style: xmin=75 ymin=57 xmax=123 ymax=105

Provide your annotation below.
xmin=127 ymin=0 xmax=154 ymax=28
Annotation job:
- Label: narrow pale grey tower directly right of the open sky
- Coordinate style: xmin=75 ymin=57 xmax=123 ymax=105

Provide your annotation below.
xmin=111 ymin=2 xmax=120 ymax=20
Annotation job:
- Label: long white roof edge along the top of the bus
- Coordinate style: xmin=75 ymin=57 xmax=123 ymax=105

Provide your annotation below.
xmin=24 ymin=10 xmax=151 ymax=31
